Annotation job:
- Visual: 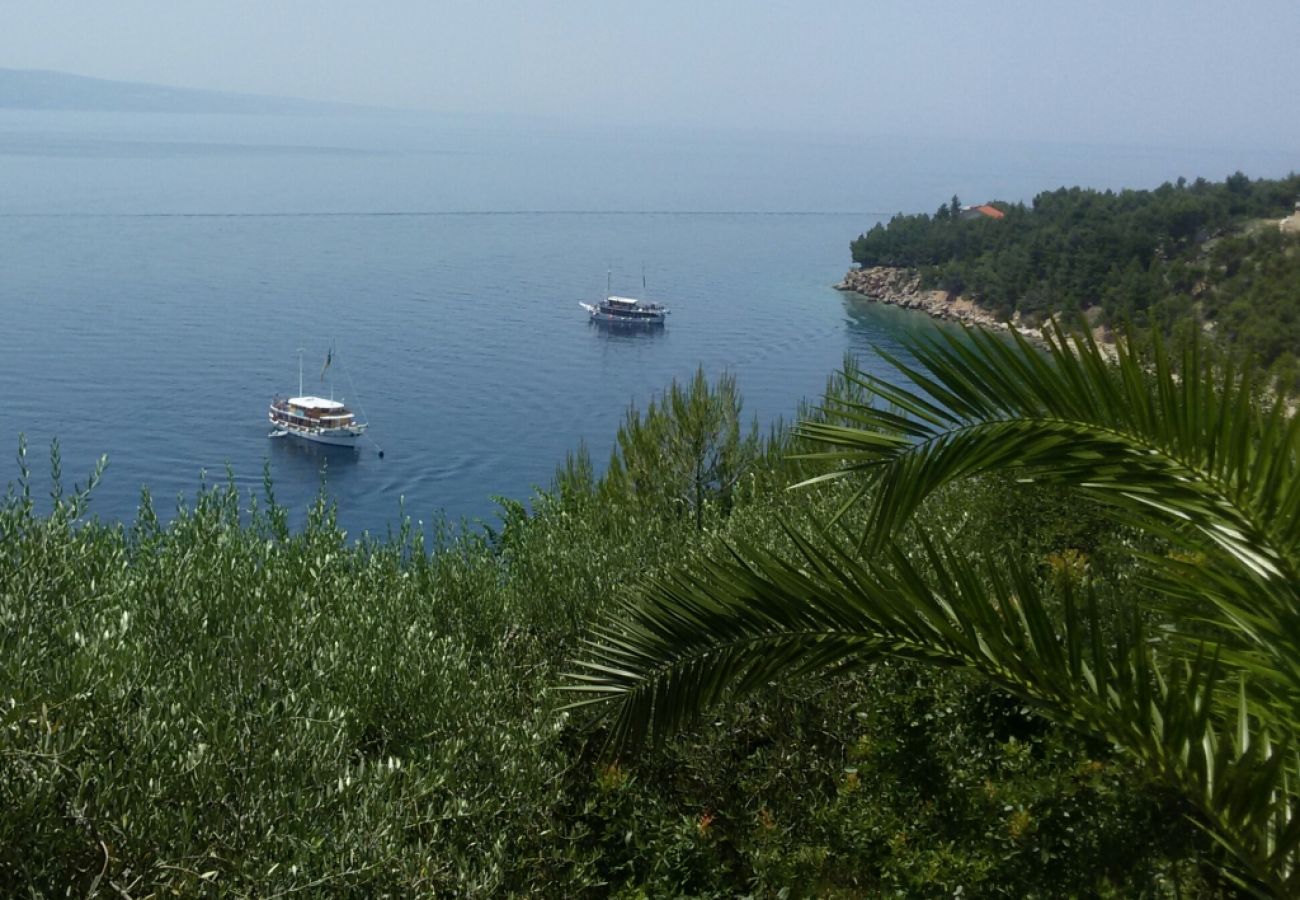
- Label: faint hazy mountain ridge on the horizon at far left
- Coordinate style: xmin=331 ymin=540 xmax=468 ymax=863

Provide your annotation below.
xmin=0 ymin=69 xmax=377 ymax=116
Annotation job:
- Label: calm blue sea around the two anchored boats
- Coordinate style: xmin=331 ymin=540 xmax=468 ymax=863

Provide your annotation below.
xmin=0 ymin=109 xmax=1295 ymax=537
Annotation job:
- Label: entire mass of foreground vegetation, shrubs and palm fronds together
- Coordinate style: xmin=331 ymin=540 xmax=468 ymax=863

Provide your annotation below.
xmin=0 ymin=326 xmax=1300 ymax=897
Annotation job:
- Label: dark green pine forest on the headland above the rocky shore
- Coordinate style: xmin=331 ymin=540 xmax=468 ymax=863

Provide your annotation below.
xmin=852 ymin=172 xmax=1300 ymax=391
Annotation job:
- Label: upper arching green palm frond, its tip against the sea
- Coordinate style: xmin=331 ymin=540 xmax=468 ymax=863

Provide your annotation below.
xmin=798 ymin=332 xmax=1300 ymax=701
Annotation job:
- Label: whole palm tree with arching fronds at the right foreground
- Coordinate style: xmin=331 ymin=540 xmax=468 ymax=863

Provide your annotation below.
xmin=568 ymin=330 xmax=1300 ymax=896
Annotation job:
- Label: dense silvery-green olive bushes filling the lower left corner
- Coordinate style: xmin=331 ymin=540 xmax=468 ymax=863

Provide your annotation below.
xmin=0 ymin=452 xmax=560 ymax=895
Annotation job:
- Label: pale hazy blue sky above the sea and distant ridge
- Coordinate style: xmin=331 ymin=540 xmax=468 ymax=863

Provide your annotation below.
xmin=0 ymin=0 xmax=1300 ymax=149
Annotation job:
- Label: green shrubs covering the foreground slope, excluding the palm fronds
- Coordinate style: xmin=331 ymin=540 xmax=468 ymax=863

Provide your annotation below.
xmin=0 ymin=367 xmax=1214 ymax=897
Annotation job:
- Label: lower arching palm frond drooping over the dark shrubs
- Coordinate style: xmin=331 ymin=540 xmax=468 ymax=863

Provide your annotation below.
xmin=566 ymin=522 xmax=1300 ymax=890
